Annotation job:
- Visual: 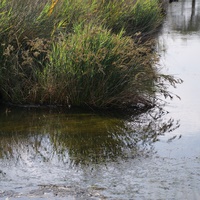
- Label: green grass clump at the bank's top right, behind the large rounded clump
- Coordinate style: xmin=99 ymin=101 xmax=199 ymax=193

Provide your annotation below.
xmin=94 ymin=0 xmax=163 ymax=35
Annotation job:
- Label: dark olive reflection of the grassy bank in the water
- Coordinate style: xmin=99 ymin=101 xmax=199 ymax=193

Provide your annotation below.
xmin=0 ymin=105 xmax=179 ymax=166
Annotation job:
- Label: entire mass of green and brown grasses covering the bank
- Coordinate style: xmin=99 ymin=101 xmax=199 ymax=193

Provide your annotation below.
xmin=0 ymin=0 xmax=178 ymax=108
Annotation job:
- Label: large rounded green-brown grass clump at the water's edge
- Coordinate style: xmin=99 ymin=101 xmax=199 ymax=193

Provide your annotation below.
xmin=40 ymin=24 xmax=156 ymax=107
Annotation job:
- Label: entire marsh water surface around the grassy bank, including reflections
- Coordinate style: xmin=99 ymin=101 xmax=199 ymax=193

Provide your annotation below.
xmin=0 ymin=0 xmax=200 ymax=200
